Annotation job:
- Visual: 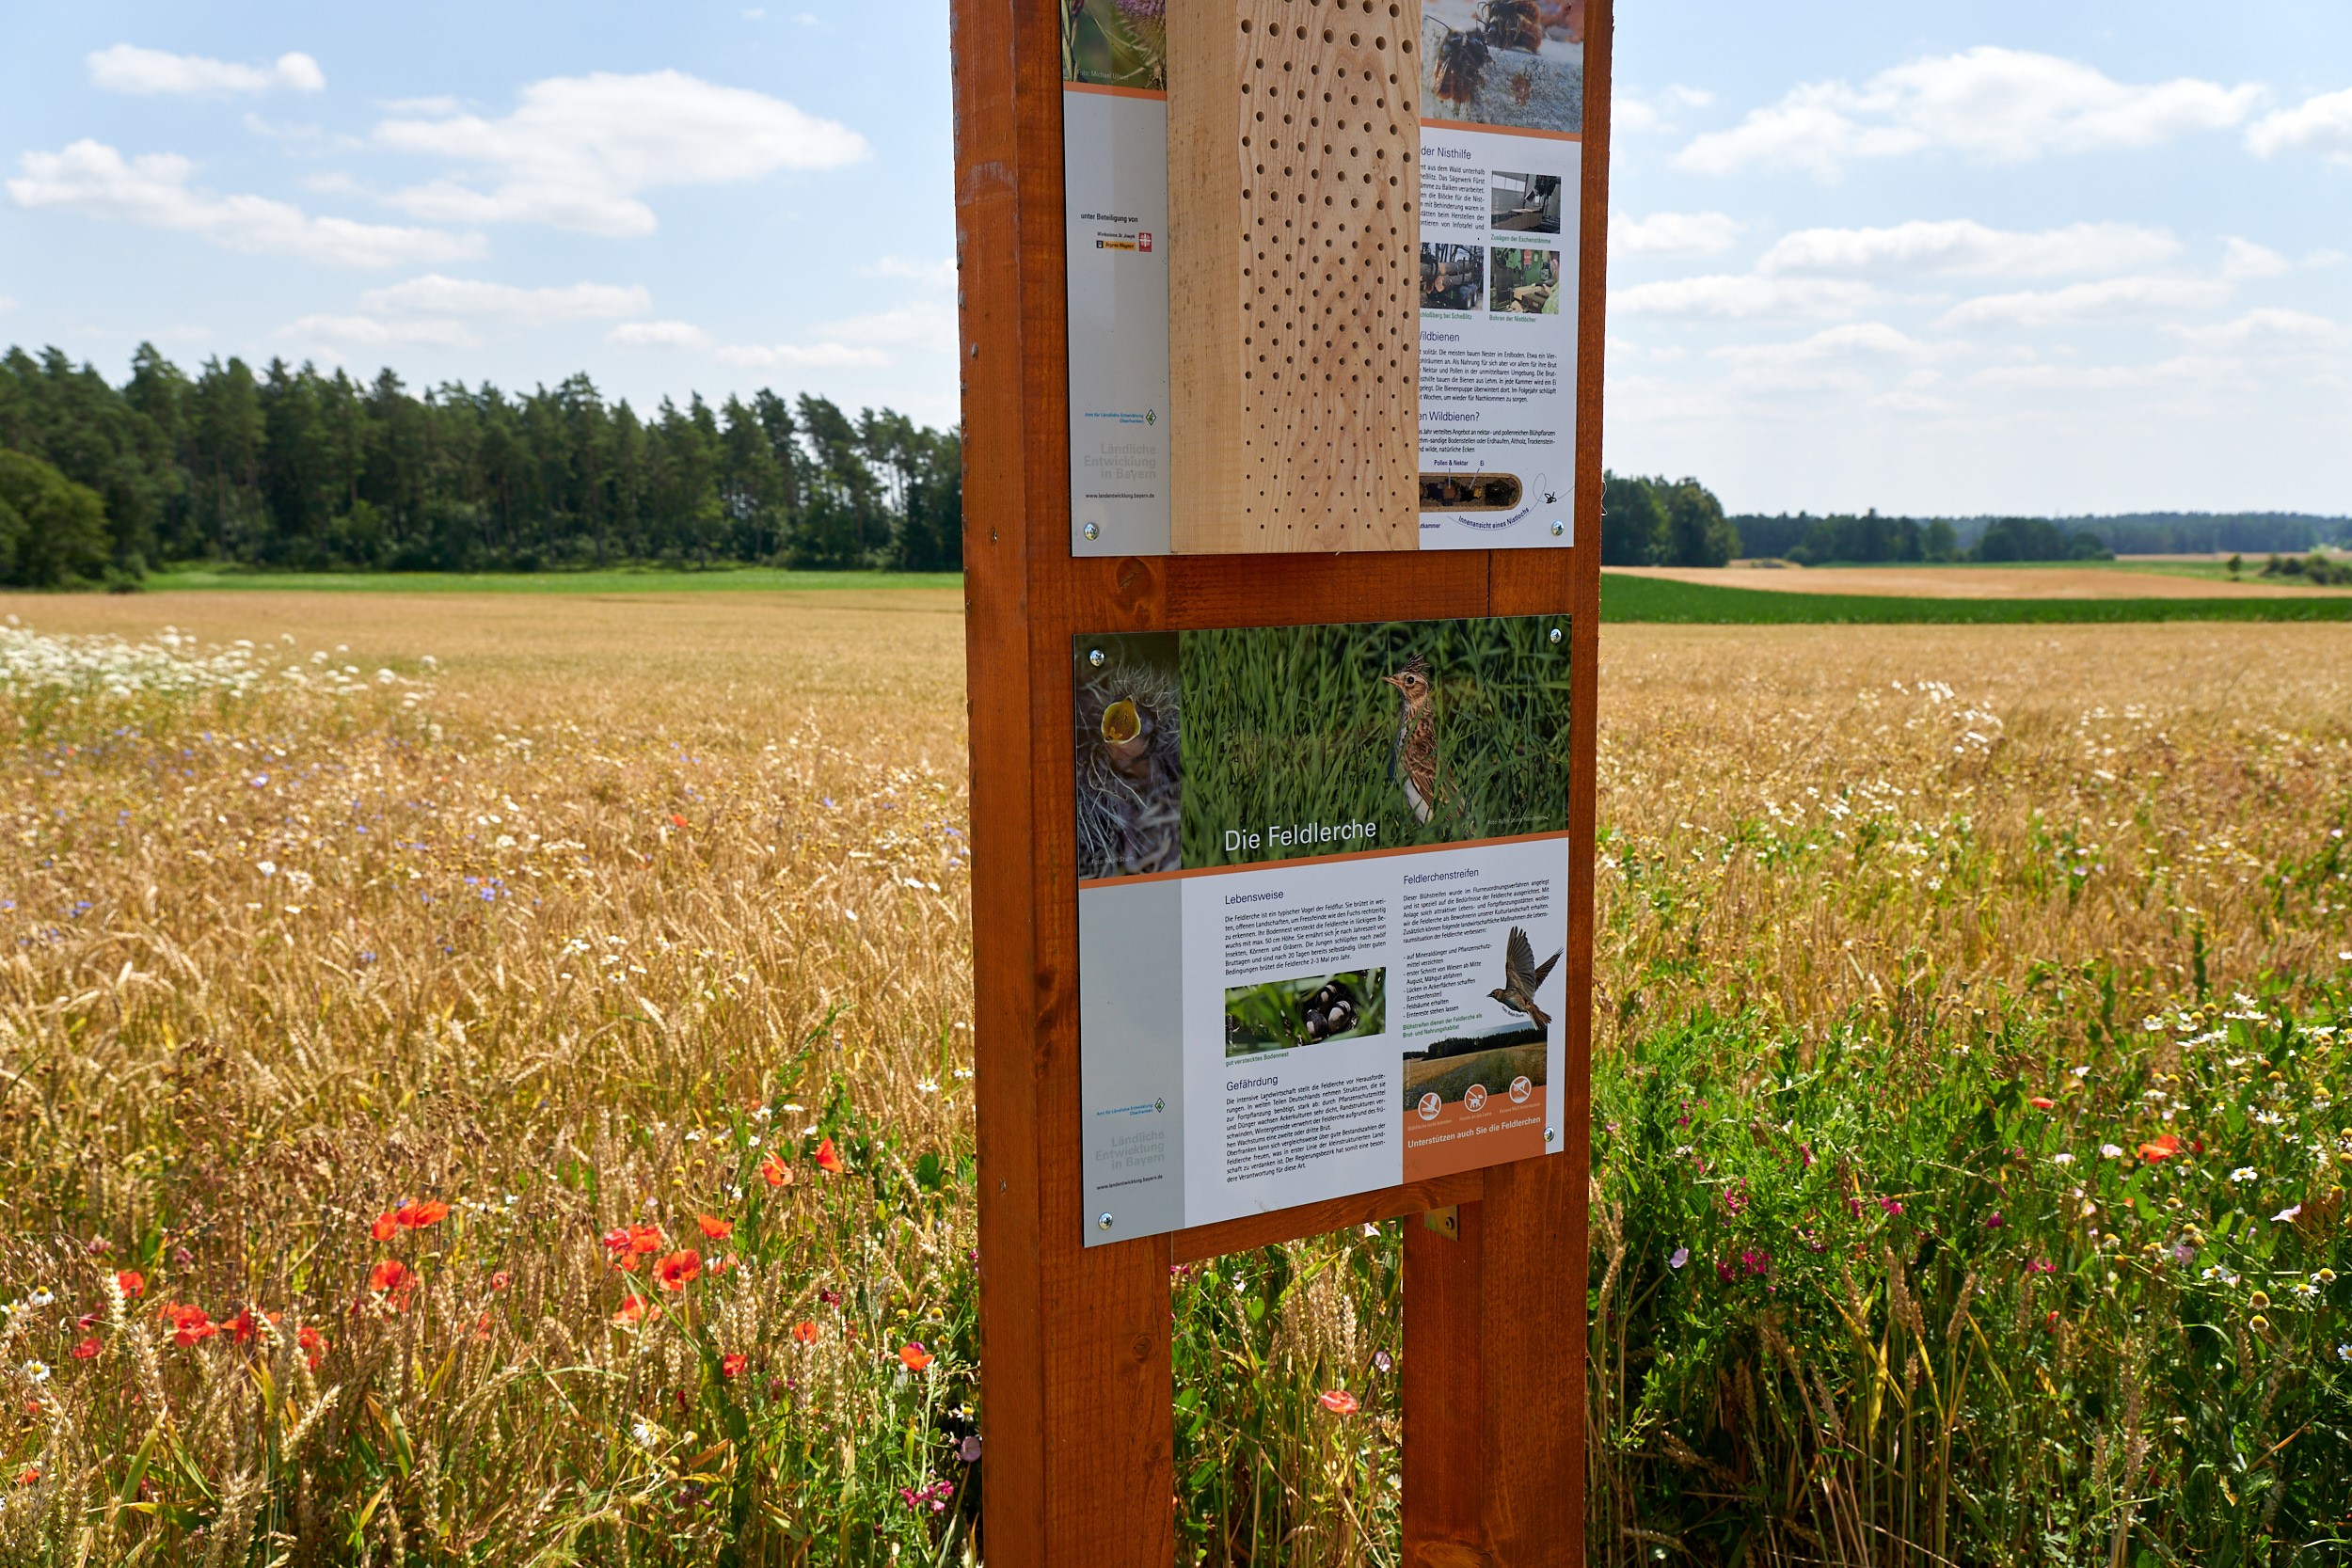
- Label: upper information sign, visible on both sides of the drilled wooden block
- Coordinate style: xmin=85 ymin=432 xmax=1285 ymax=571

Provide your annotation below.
xmin=1063 ymin=0 xmax=1583 ymax=555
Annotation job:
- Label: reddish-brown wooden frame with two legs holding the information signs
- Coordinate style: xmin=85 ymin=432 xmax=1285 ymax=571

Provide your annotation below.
xmin=953 ymin=0 xmax=1609 ymax=1568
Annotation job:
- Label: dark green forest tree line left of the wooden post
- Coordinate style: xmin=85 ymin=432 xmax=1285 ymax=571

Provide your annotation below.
xmin=0 ymin=345 xmax=964 ymax=585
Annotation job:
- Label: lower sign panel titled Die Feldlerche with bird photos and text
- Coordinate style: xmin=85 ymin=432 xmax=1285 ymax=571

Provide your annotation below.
xmin=1073 ymin=616 xmax=1571 ymax=1243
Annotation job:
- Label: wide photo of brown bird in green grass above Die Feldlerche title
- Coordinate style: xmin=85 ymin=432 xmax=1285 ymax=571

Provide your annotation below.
xmin=1184 ymin=616 xmax=1571 ymax=867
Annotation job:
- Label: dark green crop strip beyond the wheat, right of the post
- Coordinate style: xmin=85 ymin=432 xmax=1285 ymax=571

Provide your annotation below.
xmin=1602 ymin=571 xmax=2352 ymax=626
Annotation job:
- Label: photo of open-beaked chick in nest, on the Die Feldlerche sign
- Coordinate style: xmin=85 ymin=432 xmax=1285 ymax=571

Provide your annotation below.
xmin=1071 ymin=632 xmax=1184 ymax=879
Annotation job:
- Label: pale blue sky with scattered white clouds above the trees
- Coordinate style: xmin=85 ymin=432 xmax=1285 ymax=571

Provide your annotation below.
xmin=0 ymin=0 xmax=2352 ymax=513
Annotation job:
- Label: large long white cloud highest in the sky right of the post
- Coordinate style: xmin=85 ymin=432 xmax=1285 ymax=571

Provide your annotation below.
xmin=1675 ymin=44 xmax=2263 ymax=179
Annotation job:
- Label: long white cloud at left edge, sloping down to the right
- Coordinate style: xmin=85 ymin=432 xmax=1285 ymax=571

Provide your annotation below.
xmin=8 ymin=141 xmax=483 ymax=268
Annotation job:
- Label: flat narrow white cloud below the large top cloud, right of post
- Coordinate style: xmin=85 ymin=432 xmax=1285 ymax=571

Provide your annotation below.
xmin=1757 ymin=218 xmax=2181 ymax=277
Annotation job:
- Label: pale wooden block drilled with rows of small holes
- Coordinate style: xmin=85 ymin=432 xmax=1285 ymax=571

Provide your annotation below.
xmin=1169 ymin=0 xmax=1421 ymax=552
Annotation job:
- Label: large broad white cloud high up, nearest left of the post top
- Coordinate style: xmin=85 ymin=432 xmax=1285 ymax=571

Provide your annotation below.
xmin=376 ymin=71 xmax=868 ymax=235
